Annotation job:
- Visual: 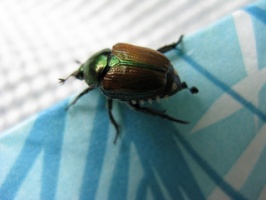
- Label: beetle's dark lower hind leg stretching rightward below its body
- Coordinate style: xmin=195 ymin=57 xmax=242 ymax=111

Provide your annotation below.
xmin=129 ymin=102 xmax=188 ymax=124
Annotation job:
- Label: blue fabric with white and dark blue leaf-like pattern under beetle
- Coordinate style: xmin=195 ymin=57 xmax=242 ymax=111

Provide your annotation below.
xmin=0 ymin=1 xmax=266 ymax=200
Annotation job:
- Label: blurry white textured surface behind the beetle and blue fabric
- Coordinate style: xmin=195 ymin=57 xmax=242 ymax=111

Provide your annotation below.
xmin=0 ymin=0 xmax=254 ymax=132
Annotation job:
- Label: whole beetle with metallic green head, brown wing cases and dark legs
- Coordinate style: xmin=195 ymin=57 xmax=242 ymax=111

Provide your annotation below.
xmin=59 ymin=36 xmax=198 ymax=143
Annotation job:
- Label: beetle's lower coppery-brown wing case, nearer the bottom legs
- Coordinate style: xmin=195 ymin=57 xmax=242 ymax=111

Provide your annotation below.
xmin=101 ymin=64 xmax=166 ymax=101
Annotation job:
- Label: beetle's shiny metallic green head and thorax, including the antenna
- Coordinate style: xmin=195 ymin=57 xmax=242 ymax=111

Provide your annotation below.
xmin=59 ymin=49 xmax=111 ymax=88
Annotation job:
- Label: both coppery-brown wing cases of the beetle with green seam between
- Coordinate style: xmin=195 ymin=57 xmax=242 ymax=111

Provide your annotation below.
xmin=101 ymin=43 xmax=171 ymax=101
